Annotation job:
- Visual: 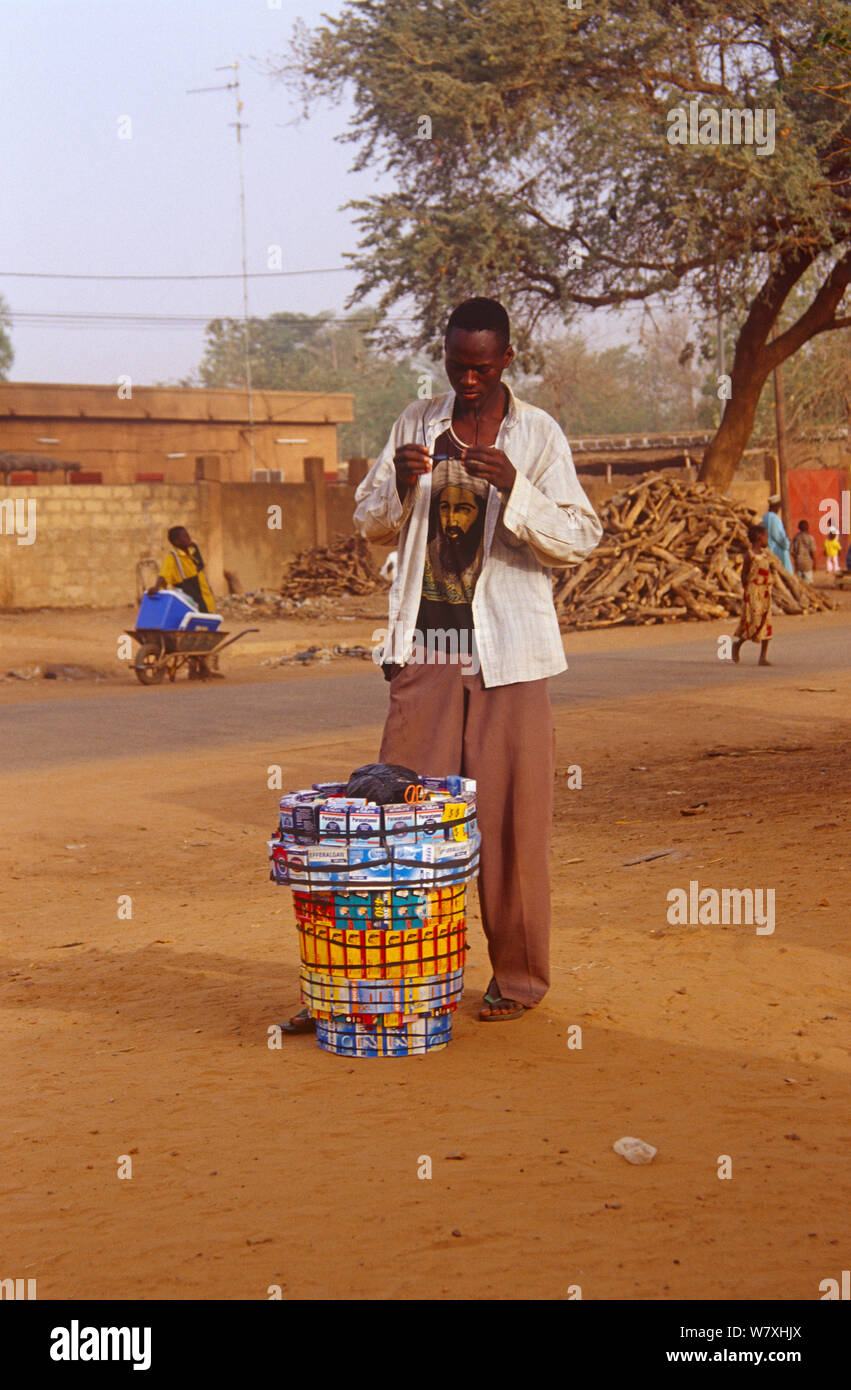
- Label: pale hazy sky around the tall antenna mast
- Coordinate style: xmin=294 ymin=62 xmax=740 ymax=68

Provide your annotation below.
xmin=0 ymin=0 xmax=386 ymax=384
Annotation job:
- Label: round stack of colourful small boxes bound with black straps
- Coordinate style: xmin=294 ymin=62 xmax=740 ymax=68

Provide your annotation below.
xmin=268 ymin=777 xmax=481 ymax=1056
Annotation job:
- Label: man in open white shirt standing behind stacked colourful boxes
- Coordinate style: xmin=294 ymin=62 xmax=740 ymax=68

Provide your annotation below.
xmin=355 ymin=299 xmax=602 ymax=1023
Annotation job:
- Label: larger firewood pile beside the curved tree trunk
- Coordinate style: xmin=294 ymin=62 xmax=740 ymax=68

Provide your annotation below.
xmin=553 ymin=474 xmax=833 ymax=628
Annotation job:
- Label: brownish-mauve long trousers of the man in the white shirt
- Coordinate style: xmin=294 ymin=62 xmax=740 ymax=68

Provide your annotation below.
xmin=380 ymin=663 xmax=555 ymax=1005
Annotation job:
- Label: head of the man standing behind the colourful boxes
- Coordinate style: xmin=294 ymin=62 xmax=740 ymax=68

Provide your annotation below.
xmin=444 ymin=299 xmax=514 ymax=413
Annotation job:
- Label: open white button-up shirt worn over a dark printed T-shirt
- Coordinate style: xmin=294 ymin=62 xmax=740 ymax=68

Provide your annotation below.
xmin=355 ymin=382 xmax=602 ymax=685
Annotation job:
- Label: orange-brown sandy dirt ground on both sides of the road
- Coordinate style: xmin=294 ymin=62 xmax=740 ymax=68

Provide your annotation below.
xmin=0 ymin=610 xmax=851 ymax=1300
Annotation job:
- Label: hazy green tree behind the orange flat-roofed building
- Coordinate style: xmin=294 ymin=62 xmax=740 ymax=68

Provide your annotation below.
xmin=199 ymin=311 xmax=428 ymax=457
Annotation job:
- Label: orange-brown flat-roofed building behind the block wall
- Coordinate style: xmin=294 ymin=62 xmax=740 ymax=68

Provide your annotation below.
xmin=0 ymin=381 xmax=353 ymax=484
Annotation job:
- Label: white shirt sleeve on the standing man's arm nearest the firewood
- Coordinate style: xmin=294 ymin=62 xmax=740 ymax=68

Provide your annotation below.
xmin=502 ymin=421 xmax=602 ymax=569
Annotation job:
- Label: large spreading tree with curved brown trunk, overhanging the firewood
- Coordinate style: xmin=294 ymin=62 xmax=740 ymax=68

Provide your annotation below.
xmin=278 ymin=0 xmax=851 ymax=488
